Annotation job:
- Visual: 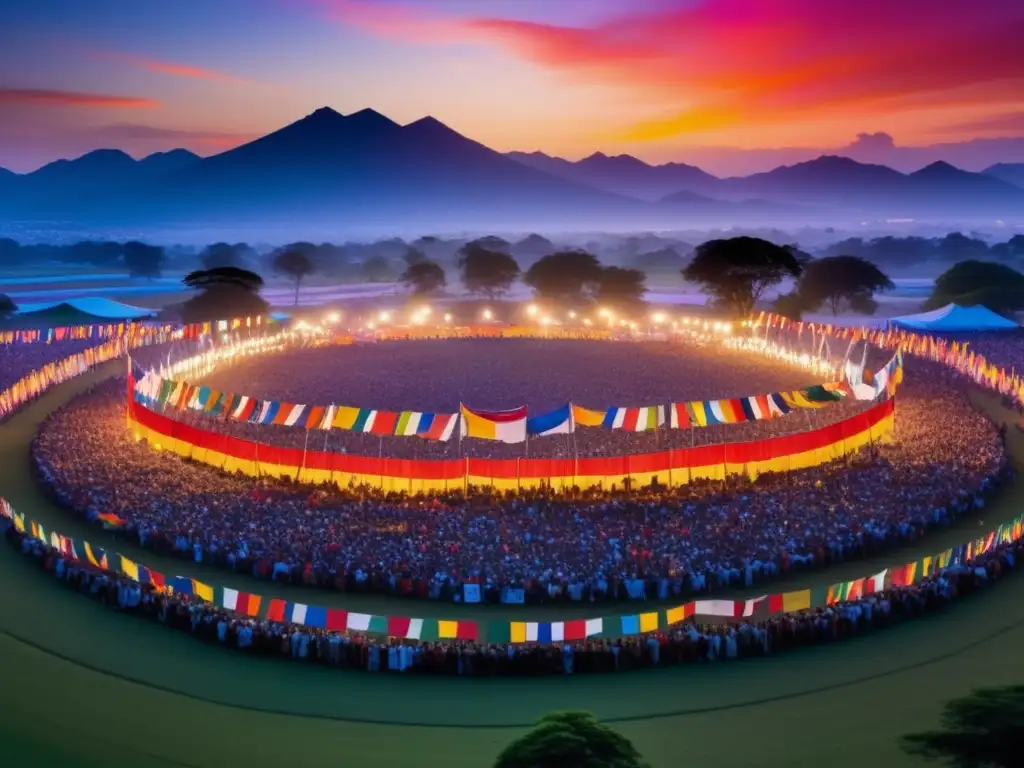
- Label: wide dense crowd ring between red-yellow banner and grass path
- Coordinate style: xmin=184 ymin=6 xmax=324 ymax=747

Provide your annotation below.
xmin=33 ymin=345 xmax=1008 ymax=602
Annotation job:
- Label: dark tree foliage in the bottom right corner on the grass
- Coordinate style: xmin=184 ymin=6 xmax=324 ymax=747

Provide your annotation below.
xmin=901 ymin=685 xmax=1024 ymax=768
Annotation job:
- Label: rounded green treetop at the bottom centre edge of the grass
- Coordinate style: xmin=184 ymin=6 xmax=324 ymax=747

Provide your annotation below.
xmin=495 ymin=712 xmax=647 ymax=768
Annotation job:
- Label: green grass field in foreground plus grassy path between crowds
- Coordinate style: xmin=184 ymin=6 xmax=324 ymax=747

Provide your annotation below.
xmin=0 ymin=369 xmax=1024 ymax=768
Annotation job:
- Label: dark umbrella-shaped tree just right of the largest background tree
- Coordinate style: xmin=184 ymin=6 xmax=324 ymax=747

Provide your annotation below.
xmin=797 ymin=256 xmax=896 ymax=314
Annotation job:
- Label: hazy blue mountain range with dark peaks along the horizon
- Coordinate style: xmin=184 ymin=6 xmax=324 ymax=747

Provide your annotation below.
xmin=0 ymin=108 xmax=1024 ymax=231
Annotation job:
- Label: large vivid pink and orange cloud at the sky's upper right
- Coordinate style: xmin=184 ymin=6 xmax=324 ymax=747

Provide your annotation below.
xmin=466 ymin=0 xmax=1024 ymax=140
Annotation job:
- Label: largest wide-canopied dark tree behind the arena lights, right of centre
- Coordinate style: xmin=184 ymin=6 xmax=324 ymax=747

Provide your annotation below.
xmin=682 ymin=237 xmax=803 ymax=316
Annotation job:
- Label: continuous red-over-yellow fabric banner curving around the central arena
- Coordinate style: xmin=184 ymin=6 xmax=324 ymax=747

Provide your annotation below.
xmin=128 ymin=398 xmax=896 ymax=493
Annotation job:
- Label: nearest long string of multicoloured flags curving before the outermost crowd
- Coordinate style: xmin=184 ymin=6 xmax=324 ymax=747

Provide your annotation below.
xmin=0 ymin=498 xmax=1024 ymax=644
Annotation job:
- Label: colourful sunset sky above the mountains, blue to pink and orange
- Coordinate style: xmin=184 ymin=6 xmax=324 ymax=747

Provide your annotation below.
xmin=6 ymin=0 xmax=1024 ymax=172
